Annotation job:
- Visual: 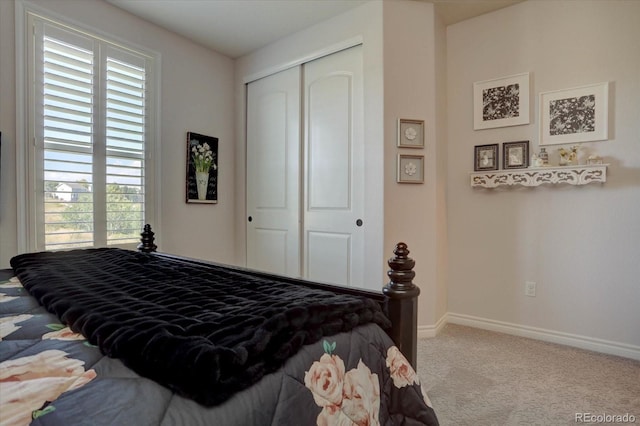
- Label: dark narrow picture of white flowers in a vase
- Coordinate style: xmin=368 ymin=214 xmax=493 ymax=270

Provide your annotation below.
xmin=186 ymin=132 xmax=218 ymax=204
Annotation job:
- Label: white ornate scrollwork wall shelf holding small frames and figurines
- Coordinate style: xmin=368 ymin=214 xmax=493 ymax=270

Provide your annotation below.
xmin=470 ymin=164 xmax=607 ymax=188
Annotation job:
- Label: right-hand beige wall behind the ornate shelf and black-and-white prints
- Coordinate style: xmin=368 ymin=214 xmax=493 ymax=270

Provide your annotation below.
xmin=447 ymin=1 xmax=640 ymax=351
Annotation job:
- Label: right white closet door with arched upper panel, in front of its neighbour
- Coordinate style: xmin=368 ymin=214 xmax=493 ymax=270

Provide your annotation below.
xmin=303 ymin=46 xmax=367 ymax=287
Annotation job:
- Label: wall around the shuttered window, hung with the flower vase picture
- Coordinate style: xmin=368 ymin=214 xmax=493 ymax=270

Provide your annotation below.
xmin=0 ymin=0 xmax=235 ymax=268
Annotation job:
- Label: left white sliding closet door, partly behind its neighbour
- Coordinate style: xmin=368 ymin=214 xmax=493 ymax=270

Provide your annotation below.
xmin=247 ymin=67 xmax=301 ymax=277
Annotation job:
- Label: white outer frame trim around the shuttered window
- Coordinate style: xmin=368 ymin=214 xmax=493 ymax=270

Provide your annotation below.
xmin=15 ymin=0 xmax=161 ymax=253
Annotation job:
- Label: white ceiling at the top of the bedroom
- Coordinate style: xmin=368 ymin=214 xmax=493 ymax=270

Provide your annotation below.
xmin=107 ymin=0 xmax=524 ymax=58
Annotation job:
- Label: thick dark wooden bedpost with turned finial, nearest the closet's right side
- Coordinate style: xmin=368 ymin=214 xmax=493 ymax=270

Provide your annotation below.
xmin=382 ymin=242 xmax=420 ymax=368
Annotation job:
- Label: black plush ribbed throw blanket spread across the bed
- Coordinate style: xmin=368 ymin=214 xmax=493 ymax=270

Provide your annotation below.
xmin=11 ymin=249 xmax=389 ymax=406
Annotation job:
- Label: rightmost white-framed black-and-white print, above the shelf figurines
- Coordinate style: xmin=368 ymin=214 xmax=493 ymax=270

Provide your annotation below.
xmin=540 ymin=82 xmax=609 ymax=145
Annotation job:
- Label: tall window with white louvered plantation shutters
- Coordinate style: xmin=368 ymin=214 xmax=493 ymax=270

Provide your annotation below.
xmin=26 ymin=12 xmax=155 ymax=250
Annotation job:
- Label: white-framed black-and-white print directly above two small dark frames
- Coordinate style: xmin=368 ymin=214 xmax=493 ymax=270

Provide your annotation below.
xmin=473 ymin=73 xmax=530 ymax=130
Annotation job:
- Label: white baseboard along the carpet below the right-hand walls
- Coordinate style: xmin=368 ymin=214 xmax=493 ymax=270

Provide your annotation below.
xmin=440 ymin=312 xmax=640 ymax=361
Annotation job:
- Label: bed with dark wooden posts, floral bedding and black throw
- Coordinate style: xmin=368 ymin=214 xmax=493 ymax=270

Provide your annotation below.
xmin=0 ymin=225 xmax=438 ymax=426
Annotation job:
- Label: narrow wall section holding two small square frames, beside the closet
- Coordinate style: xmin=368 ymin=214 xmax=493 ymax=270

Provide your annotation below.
xmin=383 ymin=1 xmax=446 ymax=335
